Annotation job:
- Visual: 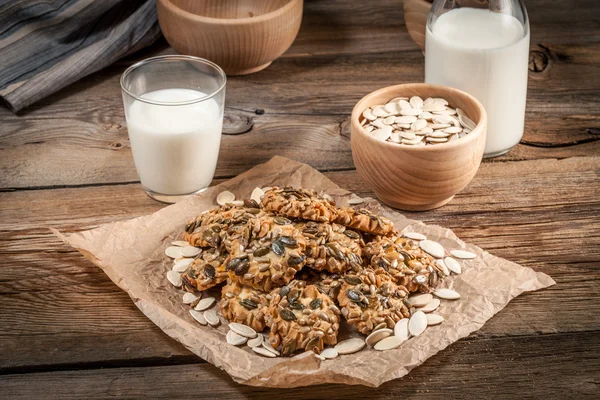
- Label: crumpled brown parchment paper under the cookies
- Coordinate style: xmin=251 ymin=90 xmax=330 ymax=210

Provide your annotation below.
xmin=54 ymin=157 xmax=554 ymax=388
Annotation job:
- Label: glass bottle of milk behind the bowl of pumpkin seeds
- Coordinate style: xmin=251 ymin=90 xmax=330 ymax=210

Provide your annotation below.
xmin=425 ymin=0 xmax=529 ymax=157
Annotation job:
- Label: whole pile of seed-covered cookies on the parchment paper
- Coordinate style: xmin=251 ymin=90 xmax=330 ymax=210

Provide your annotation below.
xmin=173 ymin=188 xmax=445 ymax=355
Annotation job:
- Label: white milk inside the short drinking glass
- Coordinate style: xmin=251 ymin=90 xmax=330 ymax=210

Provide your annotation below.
xmin=127 ymin=89 xmax=223 ymax=195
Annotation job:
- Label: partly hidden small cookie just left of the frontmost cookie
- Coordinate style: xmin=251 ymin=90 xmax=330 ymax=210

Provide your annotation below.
xmin=219 ymin=280 xmax=271 ymax=332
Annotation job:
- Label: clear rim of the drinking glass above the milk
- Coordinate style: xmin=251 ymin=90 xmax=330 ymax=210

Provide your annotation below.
xmin=119 ymin=54 xmax=227 ymax=106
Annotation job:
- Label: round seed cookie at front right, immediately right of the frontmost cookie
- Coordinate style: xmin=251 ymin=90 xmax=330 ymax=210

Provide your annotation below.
xmin=338 ymin=268 xmax=410 ymax=335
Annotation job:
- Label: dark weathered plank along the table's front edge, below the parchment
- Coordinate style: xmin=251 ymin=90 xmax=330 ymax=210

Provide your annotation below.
xmin=0 ymin=332 xmax=600 ymax=400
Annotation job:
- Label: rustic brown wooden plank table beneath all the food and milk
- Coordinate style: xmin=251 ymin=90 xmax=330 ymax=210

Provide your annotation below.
xmin=0 ymin=0 xmax=600 ymax=399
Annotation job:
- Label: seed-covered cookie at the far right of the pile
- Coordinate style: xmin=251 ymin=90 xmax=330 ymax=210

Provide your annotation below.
xmin=363 ymin=236 xmax=444 ymax=293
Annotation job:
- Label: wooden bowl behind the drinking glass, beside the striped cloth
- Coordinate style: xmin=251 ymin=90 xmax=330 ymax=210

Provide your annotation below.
xmin=157 ymin=0 xmax=303 ymax=75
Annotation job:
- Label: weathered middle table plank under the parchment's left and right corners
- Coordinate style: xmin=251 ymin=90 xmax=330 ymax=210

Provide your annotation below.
xmin=0 ymin=157 xmax=600 ymax=369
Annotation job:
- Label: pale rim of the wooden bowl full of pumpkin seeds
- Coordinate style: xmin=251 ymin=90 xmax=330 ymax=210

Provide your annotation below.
xmin=350 ymin=83 xmax=487 ymax=152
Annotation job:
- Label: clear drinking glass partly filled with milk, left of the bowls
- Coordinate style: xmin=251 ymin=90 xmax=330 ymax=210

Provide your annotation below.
xmin=121 ymin=55 xmax=227 ymax=203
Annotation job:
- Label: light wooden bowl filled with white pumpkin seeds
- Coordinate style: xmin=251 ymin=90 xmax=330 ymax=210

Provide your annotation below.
xmin=350 ymin=83 xmax=487 ymax=211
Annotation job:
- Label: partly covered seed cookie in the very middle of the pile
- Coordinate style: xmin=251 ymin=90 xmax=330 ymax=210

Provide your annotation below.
xmin=296 ymin=221 xmax=364 ymax=273
